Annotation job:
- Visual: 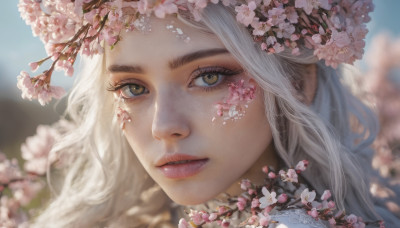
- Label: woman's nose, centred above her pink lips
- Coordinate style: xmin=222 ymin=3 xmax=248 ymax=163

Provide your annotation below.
xmin=151 ymin=90 xmax=190 ymax=141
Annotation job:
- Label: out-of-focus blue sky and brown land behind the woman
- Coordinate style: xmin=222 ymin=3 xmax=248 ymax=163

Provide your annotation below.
xmin=0 ymin=0 xmax=400 ymax=160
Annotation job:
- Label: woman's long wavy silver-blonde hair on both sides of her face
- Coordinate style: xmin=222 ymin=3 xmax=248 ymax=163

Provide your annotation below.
xmin=36 ymin=2 xmax=396 ymax=227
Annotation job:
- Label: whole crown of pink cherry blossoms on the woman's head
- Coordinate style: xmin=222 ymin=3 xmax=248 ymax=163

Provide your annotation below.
xmin=17 ymin=0 xmax=373 ymax=105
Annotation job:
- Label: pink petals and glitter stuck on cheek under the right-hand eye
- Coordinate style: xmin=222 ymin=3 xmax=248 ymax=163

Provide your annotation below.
xmin=211 ymin=79 xmax=256 ymax=125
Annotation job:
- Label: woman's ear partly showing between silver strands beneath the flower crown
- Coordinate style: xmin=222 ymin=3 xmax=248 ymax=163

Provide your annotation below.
xmin=302 ymin=64 xmax=318 ymax=105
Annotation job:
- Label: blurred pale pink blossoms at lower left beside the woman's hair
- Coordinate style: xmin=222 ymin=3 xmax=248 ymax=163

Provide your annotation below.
xmin=0 ymin=120 xmax=73 ymax=228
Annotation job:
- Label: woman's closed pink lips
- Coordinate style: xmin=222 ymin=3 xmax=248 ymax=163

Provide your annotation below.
xmin=156 ymin=154 xmax=208 ymax=179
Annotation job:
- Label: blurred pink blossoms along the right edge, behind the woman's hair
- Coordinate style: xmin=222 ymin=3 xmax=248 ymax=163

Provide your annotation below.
xmin=360 ymin=35 xmax=400 ymax=181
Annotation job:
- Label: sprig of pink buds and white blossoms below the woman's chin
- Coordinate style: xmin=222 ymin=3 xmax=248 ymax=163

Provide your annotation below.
xmin=178 ymin=160 xmax=384 ymax=228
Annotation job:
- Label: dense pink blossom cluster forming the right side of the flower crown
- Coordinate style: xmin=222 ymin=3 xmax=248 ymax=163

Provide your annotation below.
xmin=235 ymin=0 xmax=373 ymax=68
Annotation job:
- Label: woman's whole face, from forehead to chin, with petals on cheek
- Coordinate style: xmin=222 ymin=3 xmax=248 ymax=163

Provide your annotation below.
xmin=106 ymin=18 xmax=274 ymax=205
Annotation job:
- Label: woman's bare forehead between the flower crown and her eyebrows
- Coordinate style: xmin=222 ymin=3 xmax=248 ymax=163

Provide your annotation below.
xmin=106 ymin=17 xmax=224 ymax=67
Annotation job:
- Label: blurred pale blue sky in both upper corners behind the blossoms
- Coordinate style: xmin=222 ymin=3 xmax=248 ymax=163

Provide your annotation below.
xmin=0 ymin=0 xmax=400 ymax=99
